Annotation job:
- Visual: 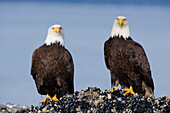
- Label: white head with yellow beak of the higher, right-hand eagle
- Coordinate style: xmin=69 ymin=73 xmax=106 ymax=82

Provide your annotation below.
xmin=111 ymin=16 xmax=130 ymax=39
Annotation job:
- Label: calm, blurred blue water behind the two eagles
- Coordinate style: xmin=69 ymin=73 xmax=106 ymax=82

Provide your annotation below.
xmin=0 ymin=0 xmax=170 ymax=105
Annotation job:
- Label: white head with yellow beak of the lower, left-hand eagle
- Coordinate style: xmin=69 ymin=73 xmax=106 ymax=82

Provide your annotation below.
xmin=45 ymin=24 xmax=64 ymax=46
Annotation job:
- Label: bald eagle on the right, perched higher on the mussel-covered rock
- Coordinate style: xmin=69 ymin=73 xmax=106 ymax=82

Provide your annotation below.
xmin=104 ymin=16 xmax=154 ymax=98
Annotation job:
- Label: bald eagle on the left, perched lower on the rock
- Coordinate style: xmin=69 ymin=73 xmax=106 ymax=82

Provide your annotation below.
xmin=31 ymin=25 xmax=74 ymax=102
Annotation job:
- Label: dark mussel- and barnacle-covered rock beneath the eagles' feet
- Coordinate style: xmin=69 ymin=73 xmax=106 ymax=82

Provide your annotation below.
xmin=0 ymin=88 xmax=170 ymax=113
